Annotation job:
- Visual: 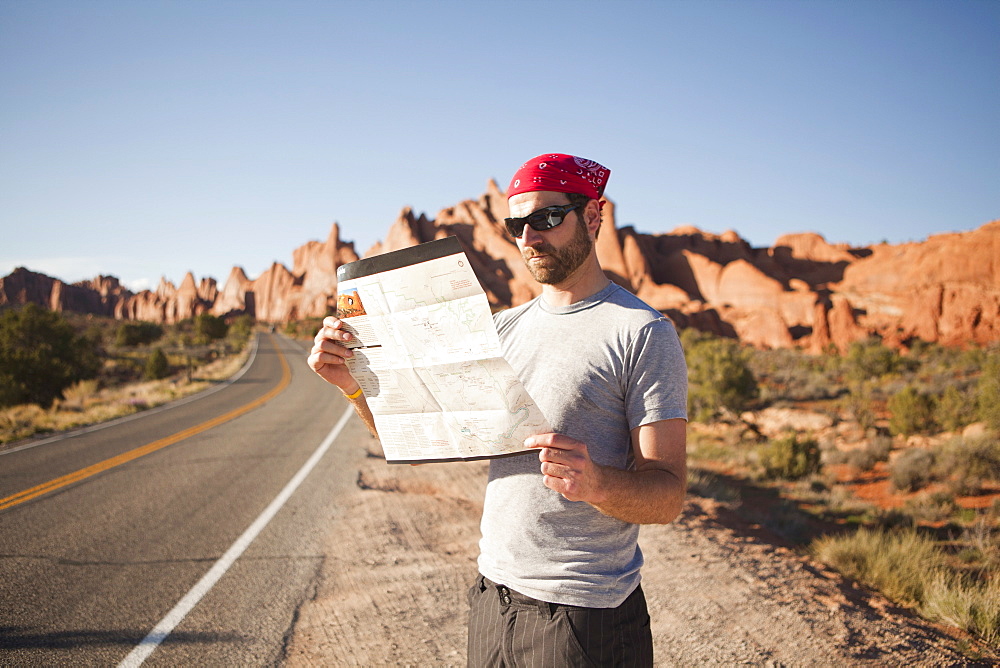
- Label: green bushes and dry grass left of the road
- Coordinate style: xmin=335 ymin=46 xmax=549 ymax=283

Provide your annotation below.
xmin=0 ymin=304 xmax=254 ymax=447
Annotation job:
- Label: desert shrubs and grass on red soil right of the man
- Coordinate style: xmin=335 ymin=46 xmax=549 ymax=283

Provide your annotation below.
xmin=681 ymin=330 xmax=1000 ymax=654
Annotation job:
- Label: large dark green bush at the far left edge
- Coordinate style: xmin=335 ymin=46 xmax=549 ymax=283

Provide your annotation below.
xmin=0 ymin=304 xmax=101 ymax=406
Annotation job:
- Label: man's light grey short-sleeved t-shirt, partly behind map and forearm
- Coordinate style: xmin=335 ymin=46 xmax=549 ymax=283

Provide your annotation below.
xmin=479 ymin=284 xmax=687 ymax=608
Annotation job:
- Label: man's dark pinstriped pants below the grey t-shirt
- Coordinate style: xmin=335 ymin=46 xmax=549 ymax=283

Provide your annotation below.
xmin=469 ymin=575 xmax=653 ymax=668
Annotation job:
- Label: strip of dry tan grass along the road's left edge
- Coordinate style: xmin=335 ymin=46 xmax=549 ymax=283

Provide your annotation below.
xmin=0 ymin=345 xmax=251 ymax=447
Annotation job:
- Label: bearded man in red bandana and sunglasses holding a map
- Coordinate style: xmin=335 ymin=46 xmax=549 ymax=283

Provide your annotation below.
xmin=309 ymin=154 xmax=687 ymax=666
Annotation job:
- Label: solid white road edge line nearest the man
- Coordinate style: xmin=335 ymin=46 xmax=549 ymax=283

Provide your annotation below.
xmin=118 ymin=406 xmax=354 ymax=668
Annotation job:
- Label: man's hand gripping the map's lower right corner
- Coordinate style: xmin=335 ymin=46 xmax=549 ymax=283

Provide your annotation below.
xmin=524 ymin=434 xmax=605 ymax=504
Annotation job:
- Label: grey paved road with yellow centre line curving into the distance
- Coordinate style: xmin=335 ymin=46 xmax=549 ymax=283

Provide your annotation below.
xmin=0 ymin=335 xmax=364 ymax=666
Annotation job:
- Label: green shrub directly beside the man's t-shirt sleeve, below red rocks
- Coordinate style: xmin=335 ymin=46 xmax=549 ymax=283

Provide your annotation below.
xmin=682 ymin=329 xmax=760 ymax=422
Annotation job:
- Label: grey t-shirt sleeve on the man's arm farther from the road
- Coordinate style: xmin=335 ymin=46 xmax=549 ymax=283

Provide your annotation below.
xmin=625 ymin=318 xmax=687 ymax=431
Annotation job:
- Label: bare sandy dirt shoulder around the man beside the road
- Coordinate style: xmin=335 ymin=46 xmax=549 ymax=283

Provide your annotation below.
xmin=286 ymin=439 xmax=993 ymax=666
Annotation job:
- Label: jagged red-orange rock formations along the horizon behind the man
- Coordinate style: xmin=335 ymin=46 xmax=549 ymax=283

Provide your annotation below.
xmin=0 ymin=181 xmax=1000 ymax=351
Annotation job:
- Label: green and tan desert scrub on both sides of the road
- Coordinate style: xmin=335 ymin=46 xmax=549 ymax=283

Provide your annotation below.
xmin=0 ymin=306 xmax=1000 ymax=654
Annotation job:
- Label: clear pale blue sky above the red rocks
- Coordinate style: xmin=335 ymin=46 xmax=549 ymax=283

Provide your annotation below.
xmin=0 ymin=0 xmax=1000 ymax=288
